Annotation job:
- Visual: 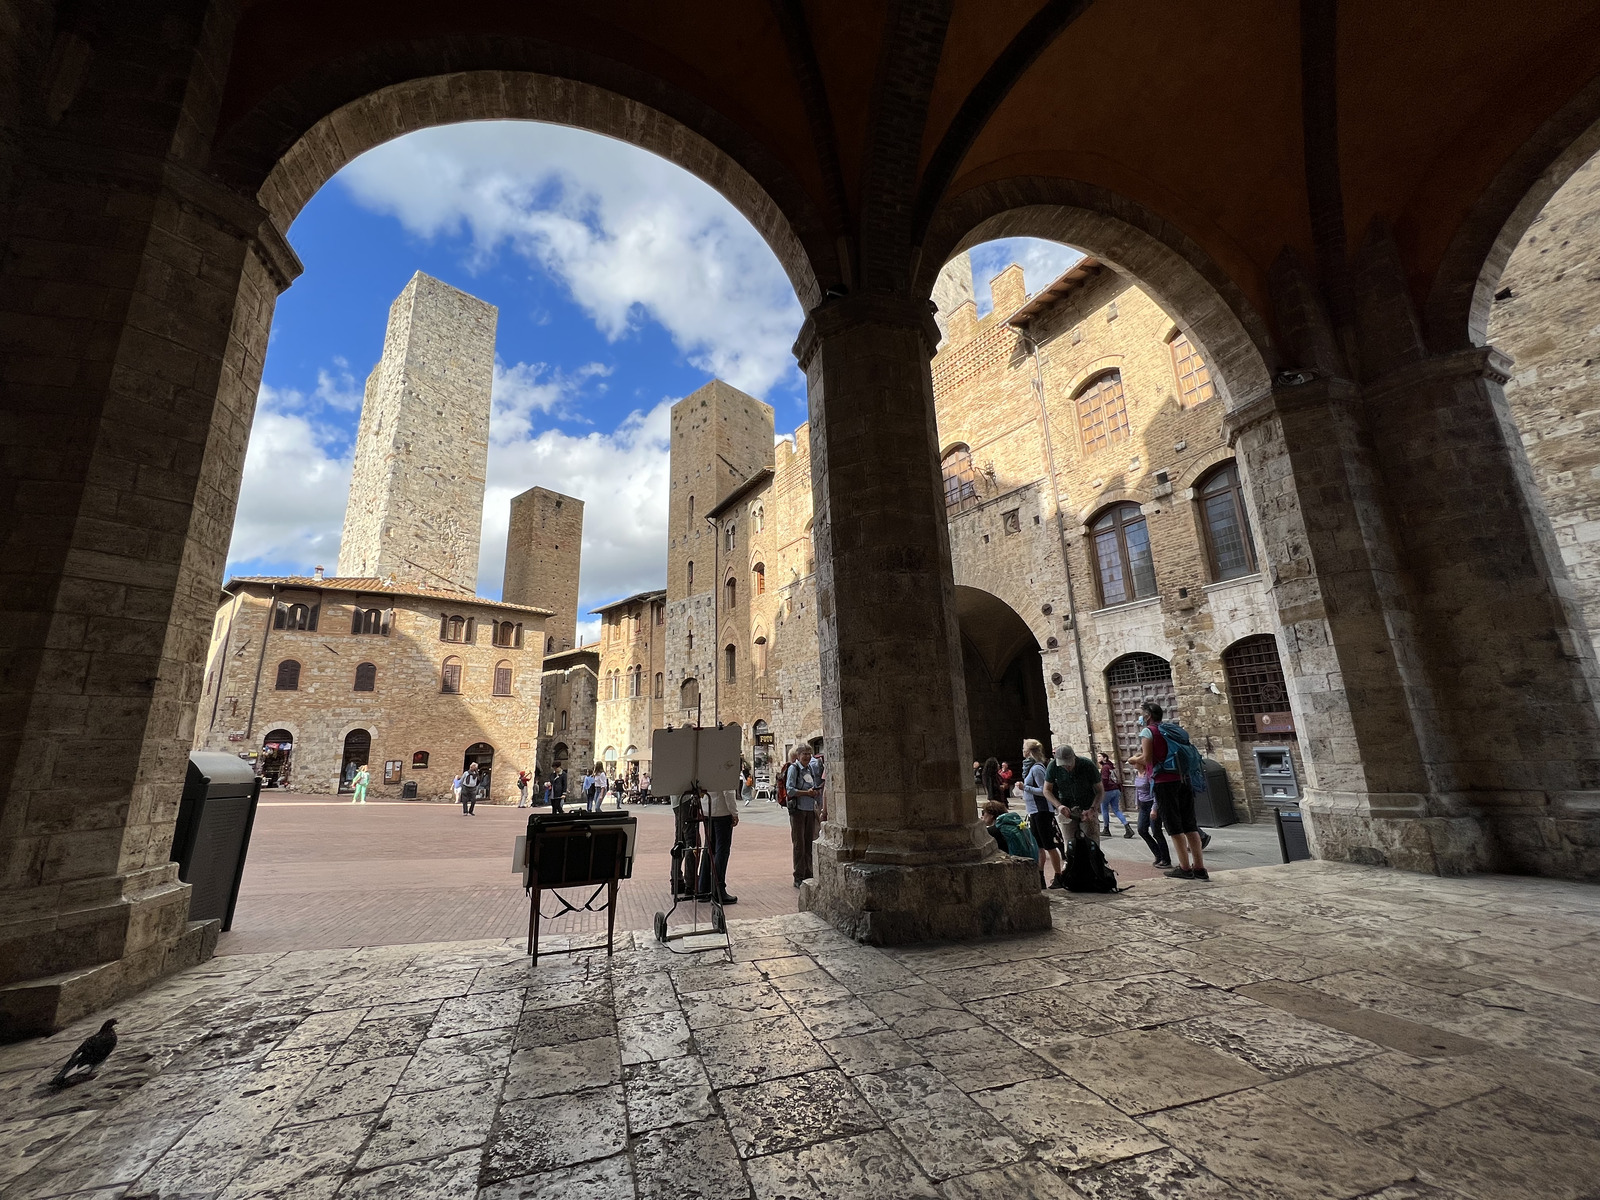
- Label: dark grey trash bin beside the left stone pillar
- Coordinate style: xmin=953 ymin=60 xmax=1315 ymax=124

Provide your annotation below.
xmin=173 ymin=750 xmax=261 ymax=930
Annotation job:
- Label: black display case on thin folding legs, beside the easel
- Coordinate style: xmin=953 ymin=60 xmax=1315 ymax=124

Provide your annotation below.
xmin=517 ymin=813 xmax=638 ymax=965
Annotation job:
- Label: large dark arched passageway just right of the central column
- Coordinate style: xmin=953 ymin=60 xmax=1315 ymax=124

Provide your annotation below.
xmin=955 ymin=586 xmax=1050 ymax=762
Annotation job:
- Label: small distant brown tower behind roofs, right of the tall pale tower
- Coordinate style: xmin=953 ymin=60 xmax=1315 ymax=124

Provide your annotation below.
xmin=501 ymin=488 xmax=584 ymax=654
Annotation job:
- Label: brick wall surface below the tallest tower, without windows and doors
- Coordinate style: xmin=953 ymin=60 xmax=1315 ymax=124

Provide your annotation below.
xmin=195 ymin=584 xmax=544 ymax=802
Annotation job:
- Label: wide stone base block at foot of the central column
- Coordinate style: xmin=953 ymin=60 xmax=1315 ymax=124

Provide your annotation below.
xmin=800 ymin=846 xmax=1050 ymax=946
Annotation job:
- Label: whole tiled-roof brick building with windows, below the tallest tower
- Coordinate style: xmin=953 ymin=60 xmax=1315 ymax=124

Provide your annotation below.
xmin=195 ymin=576 xmax=546 ymax=802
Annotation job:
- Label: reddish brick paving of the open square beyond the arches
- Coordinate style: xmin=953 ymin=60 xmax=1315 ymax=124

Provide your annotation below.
xmin=218 ymin=792 xmax=1278 ymax=954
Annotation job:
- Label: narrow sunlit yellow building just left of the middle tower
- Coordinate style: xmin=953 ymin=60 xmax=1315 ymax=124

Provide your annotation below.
xmin=594 ymin=589 xmax=667 ymax=778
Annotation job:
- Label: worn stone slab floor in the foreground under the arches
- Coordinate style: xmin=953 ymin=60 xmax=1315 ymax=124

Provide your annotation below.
xmin=0 ymin=862 xmax=1600 ymax=1200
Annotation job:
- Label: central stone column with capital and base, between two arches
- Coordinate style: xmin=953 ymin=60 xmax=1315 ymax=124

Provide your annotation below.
xmin=795 ymin=293 xmax=1050 ymax=944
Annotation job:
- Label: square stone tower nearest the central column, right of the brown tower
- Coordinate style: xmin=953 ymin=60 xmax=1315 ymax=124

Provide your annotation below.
xmin=664 ymin=379 xmax=773 ymax=722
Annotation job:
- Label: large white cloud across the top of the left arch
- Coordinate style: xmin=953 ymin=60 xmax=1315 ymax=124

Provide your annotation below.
xmin=338 ymin=122 xmax=802 ymax=395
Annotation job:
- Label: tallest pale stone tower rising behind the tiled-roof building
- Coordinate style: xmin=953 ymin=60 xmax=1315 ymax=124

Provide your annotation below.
xmin=339 ymin=272 xmax=492 ymax=592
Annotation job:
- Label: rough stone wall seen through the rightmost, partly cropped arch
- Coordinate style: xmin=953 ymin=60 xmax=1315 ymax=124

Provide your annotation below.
xmin=1488 ymin=158 xmax=1600 ymax=662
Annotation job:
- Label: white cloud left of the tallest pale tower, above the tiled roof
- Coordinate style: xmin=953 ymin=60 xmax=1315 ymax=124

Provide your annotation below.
xmin=227 ymin=384 xmax=350 ymax=574
